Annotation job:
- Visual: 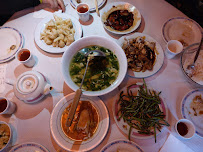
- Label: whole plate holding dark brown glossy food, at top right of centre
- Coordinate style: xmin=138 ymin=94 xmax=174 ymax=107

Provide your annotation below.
xmin=101 ymin=2 xmax=141 ymax=34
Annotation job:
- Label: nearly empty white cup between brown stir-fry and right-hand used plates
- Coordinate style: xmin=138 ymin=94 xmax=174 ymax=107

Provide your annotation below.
xmin=165 ymin=40 xmax=183 ymax=59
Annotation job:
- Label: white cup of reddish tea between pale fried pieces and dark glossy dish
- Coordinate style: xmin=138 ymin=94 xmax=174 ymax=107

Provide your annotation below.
xmin=76 ymin=3 xmax=90 ymax=22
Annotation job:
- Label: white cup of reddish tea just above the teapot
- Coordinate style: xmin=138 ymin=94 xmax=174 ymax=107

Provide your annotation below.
xmin=16 ymin=49 xmax=35 ymax=68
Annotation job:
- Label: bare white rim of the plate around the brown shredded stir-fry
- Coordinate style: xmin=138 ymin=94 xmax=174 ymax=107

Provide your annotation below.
xmin=117 ymin=32 xmax=164 ymax=78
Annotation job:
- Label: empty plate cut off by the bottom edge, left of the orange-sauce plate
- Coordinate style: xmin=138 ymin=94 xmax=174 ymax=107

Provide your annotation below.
xmin=9 ymin=142 xmax=49 ymax=152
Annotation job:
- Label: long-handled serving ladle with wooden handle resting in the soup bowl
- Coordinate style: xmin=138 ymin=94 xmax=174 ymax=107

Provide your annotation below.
xmin=66 ymin=50 xmax=106 ymax=127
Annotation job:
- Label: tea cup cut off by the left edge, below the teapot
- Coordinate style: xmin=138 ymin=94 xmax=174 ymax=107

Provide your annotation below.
xmin=0 ymin=97 xmax=16 ymax=114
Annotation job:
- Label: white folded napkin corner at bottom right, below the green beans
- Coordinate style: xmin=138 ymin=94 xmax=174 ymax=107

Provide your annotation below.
xmin=159 ymin=134 xmax=194 ymax=152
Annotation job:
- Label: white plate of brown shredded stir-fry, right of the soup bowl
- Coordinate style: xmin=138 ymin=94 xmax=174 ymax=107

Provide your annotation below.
xmin=118 ymin=33 xmax=164 ymax=78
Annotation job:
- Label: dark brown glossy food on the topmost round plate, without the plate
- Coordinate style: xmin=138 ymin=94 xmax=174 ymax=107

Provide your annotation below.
xmin=104 ymin=10 xmax=134 ymax=31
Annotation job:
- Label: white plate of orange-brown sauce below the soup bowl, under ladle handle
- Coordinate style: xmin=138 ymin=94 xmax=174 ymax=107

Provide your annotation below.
xmin=50 ymin=92 xmax=109 ymax=151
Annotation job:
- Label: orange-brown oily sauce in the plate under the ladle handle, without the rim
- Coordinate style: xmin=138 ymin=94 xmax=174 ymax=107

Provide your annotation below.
xmin=61 ymin=101 xmax=99 ymax=141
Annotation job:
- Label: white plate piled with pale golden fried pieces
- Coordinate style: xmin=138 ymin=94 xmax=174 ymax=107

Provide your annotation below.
xmin=35 ymin=13 xmax=82 ymax=53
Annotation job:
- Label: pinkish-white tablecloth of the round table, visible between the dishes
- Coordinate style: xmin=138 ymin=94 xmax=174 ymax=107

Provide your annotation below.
xmin=0 ymin=0 xmax=203 ymax=152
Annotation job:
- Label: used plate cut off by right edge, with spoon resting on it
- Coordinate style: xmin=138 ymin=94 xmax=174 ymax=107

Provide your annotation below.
xmin=181 ymin=43 xmax=203 ymax=87
